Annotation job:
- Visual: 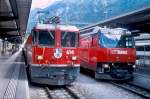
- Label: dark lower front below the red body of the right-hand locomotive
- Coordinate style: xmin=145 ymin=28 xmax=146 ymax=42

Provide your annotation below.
xmin=95 ymin=63 xmax=134 ymax=80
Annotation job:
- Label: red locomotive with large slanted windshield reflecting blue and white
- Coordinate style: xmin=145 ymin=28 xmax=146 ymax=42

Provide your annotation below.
xmin=80 ymin=26 xmax=136 ymax=80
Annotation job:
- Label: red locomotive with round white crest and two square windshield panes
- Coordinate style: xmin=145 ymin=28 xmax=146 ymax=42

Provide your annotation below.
xmin=23 ymin=24 xmax=80 ymax=85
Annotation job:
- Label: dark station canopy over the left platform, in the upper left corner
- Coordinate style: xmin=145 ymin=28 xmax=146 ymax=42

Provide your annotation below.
xmin=0 ymin=0 xmax=32 ymax=43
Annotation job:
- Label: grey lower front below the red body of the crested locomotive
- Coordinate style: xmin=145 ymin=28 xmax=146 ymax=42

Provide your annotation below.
xmin=30 ymin=65 xmax=80 ymax=85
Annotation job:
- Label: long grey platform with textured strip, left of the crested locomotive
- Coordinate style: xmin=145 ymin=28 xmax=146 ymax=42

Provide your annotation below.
xmin=0 ymin=52 xmax=30 ymax=99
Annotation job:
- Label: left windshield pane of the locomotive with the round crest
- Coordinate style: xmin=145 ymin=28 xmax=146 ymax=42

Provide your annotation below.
xmin=38 ymin=30 xmax=55 ymax=46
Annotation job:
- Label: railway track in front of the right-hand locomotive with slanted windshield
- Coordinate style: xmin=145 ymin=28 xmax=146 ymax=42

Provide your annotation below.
xmin=111 ymin=82 xmax=150 ymax=99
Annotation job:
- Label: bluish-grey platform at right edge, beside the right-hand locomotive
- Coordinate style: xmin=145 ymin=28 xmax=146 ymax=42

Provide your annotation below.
xmin=131 ymin=66 xmax=150 ymax=90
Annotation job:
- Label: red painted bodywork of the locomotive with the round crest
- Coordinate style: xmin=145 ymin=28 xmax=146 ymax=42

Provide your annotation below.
xmin=25 ymin=24 xmax=80 ymax=66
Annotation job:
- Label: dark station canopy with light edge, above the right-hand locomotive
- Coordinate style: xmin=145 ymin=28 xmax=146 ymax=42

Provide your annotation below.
xmin=81 ymin=6 xmax=150 ymax=36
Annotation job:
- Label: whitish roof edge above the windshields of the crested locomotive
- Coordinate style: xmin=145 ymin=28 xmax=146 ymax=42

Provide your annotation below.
xmin=35 ymin=24 xmax=79 ymax=31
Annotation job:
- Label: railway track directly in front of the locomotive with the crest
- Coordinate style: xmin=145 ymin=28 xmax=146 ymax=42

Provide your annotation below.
xmin=45 ymin=87 xmax=85 ymax=99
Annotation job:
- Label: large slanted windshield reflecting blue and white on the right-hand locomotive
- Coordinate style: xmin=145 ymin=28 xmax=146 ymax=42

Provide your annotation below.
xmin=99 ymin=30 xmax=134 ymax=48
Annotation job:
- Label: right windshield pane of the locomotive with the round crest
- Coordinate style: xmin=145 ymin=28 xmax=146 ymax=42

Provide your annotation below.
xmin=61 ymin=32 xmax=78 ymax=47
